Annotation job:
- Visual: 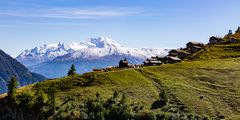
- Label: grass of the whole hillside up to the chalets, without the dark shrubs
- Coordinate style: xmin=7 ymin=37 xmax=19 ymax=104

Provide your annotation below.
xmin=0 ymin=39 xmax=240 ymax=120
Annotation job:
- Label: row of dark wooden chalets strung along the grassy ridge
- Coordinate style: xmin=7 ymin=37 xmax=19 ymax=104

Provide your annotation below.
xmin=93 ymin=27 xmax=240 ymax=72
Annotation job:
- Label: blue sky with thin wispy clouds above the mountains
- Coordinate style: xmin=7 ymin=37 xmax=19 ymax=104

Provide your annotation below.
xmin=0 ymin=0 xmax=240 ymax=56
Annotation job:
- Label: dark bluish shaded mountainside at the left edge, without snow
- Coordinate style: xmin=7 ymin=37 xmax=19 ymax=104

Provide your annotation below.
xmin=0 ymin=50 xmax=46 ymax=93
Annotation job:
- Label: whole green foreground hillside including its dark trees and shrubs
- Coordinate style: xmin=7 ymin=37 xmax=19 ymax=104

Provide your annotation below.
xmin=0 ymin=28 xmax=240 ymax=120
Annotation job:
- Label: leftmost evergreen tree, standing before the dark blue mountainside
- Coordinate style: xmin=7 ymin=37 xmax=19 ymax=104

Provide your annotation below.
xmin=8 ymin=77 xmax=18 ymax=98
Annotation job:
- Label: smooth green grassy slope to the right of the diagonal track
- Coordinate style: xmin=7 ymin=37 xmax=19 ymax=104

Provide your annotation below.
xmin=141 ymin=59 xmax=240 ymax=119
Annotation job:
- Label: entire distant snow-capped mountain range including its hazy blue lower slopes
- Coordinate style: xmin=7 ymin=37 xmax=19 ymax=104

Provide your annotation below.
xmin=16 ymin=37 xmax=169 ymax=77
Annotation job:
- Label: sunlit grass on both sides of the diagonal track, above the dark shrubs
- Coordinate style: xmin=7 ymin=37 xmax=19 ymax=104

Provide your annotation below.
xmin=0 ymin=58 xmax=240 ymax=119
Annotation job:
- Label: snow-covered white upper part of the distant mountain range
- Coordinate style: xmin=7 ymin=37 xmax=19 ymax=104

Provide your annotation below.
xmin=16 ymin=37 xmax=170 ymax=66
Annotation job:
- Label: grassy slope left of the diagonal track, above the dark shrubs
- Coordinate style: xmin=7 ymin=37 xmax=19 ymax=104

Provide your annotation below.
xmin=16 ymin=69 xmax=158 ymax=108
